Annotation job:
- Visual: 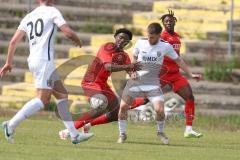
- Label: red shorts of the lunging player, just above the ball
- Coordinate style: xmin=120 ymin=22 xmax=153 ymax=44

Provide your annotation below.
xmin=82 ymin=83 xmax=118 ymax=107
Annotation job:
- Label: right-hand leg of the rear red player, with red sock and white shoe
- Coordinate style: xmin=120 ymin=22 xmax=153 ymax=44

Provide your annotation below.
xmin=172 ymin=76 xmax=202 ymax=138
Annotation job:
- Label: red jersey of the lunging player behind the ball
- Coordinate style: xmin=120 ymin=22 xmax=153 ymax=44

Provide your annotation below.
xmin=82 ymin=43 xmax=131 ymax=89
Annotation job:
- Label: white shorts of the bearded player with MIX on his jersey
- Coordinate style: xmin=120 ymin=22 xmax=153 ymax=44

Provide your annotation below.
xmin=123 ymin=81 xmax=164 ymax=103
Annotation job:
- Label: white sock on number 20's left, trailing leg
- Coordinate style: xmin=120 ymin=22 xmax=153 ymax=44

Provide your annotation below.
xmin=9 ymin=98 xmax=44 ymax=130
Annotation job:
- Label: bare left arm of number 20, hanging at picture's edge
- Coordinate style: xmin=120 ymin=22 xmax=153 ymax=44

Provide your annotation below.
xmin=0 ymin=29 xmax=25 ymax=78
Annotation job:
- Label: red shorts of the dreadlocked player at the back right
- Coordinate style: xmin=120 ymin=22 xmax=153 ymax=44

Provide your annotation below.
xmin=160 ymin=72 xmax=189 ymax=92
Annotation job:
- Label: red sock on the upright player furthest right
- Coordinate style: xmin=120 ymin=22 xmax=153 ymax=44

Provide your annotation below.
xmin=185 ymin=100 xmax=195 ymax=126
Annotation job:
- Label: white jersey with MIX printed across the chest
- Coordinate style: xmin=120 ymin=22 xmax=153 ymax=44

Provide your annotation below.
xmin=133 ymin=39 xmax=179 ymax=85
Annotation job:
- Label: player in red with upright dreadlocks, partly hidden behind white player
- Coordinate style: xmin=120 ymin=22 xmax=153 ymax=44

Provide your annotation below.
xmin=160 ymin=10 xmax=202 ymax=138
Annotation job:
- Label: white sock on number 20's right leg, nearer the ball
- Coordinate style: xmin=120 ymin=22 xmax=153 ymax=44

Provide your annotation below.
xmin=57 ymin=99 xmax=78 ymax=137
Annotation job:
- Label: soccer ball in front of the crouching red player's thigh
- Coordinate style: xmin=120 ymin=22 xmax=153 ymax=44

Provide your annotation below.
xmin=90 ymin=94 xmax=108 ymax=110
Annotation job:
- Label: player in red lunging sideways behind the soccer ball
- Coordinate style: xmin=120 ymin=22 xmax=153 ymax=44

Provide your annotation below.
xmin=59 ymin=28 xmax=142 ymax=139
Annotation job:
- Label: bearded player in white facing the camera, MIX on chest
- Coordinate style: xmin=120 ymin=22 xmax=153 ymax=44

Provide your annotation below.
xmin=117 ymin=23 xmax=200 ymax=144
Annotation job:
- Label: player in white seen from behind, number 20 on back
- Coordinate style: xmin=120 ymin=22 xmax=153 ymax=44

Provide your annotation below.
xmin=0 ymin=0 xmax=92 ymax=144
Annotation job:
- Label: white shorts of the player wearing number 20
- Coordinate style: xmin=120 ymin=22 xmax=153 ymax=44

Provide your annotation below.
xmin=28 ymin=60 xmax=60 ymax=89
